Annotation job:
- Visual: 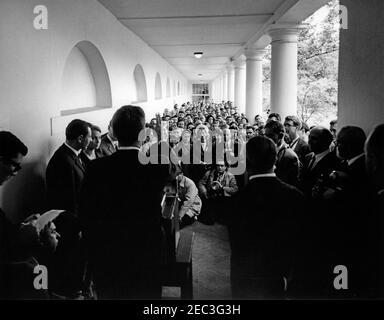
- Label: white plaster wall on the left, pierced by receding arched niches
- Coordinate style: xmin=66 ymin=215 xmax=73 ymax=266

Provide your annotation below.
xmin=0 ymin=0 xmax=190 ymax=221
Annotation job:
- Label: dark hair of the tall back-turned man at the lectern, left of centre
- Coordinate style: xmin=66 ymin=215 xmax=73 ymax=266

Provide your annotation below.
xmin=112 ymin=105 xmax=145 ymax=144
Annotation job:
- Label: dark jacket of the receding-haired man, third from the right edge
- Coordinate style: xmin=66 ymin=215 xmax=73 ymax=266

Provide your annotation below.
xmin=299 ymin=151 xmax=343 ymax=197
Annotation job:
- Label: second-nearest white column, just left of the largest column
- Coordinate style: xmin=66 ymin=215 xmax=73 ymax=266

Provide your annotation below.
xmin=244 ymin=48 xmax=265 ymax=123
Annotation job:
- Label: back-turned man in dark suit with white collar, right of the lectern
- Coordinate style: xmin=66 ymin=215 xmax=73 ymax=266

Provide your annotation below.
xmin=228 ymin=136 xmax=303 ymax=299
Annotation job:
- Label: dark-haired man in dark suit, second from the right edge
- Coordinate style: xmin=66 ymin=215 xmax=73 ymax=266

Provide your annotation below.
xmin=321 ymin=126 xmax=372 ymax=298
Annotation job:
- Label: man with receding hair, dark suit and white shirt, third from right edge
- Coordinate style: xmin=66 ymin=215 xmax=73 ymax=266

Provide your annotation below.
xmin=299 ymin=127 xmax=342 ymax=198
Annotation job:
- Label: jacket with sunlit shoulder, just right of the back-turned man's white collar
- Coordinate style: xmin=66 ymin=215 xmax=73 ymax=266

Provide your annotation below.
xmin=275 ymin=145 xmax=300 ymax=186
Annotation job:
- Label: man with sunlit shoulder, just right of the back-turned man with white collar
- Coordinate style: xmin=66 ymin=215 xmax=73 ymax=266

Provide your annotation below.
xmin=265 ymin=120 xmax=300 ymax=186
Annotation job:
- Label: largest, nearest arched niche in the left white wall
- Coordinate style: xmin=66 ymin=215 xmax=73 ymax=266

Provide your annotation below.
xmin=60 ymin=41 xmax=112 ymax=116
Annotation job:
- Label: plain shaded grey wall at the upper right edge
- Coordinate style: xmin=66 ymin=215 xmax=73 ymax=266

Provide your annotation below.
xmin=338 ymin=0 xmax=384 ymax=133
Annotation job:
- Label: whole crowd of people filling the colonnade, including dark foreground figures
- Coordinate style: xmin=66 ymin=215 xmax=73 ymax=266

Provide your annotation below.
xmin=0 ymin=101 xmax=384 ymax=299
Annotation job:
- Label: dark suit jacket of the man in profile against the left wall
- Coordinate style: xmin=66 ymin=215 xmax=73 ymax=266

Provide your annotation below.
xmin=46 ymin=144 xmax=85 ymax=214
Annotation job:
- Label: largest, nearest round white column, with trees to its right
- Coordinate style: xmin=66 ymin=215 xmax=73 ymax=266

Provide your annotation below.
xmin=269 ymin=26 xmax=301 ymax=120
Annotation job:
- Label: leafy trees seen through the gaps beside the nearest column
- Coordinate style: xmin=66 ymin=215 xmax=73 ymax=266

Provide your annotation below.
xmin=263 ymin=0 xmax=339 ymax=125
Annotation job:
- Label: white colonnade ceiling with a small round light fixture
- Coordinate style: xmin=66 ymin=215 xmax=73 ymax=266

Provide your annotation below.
xmin=98 ymin=0 xmax=327 ymax=81
